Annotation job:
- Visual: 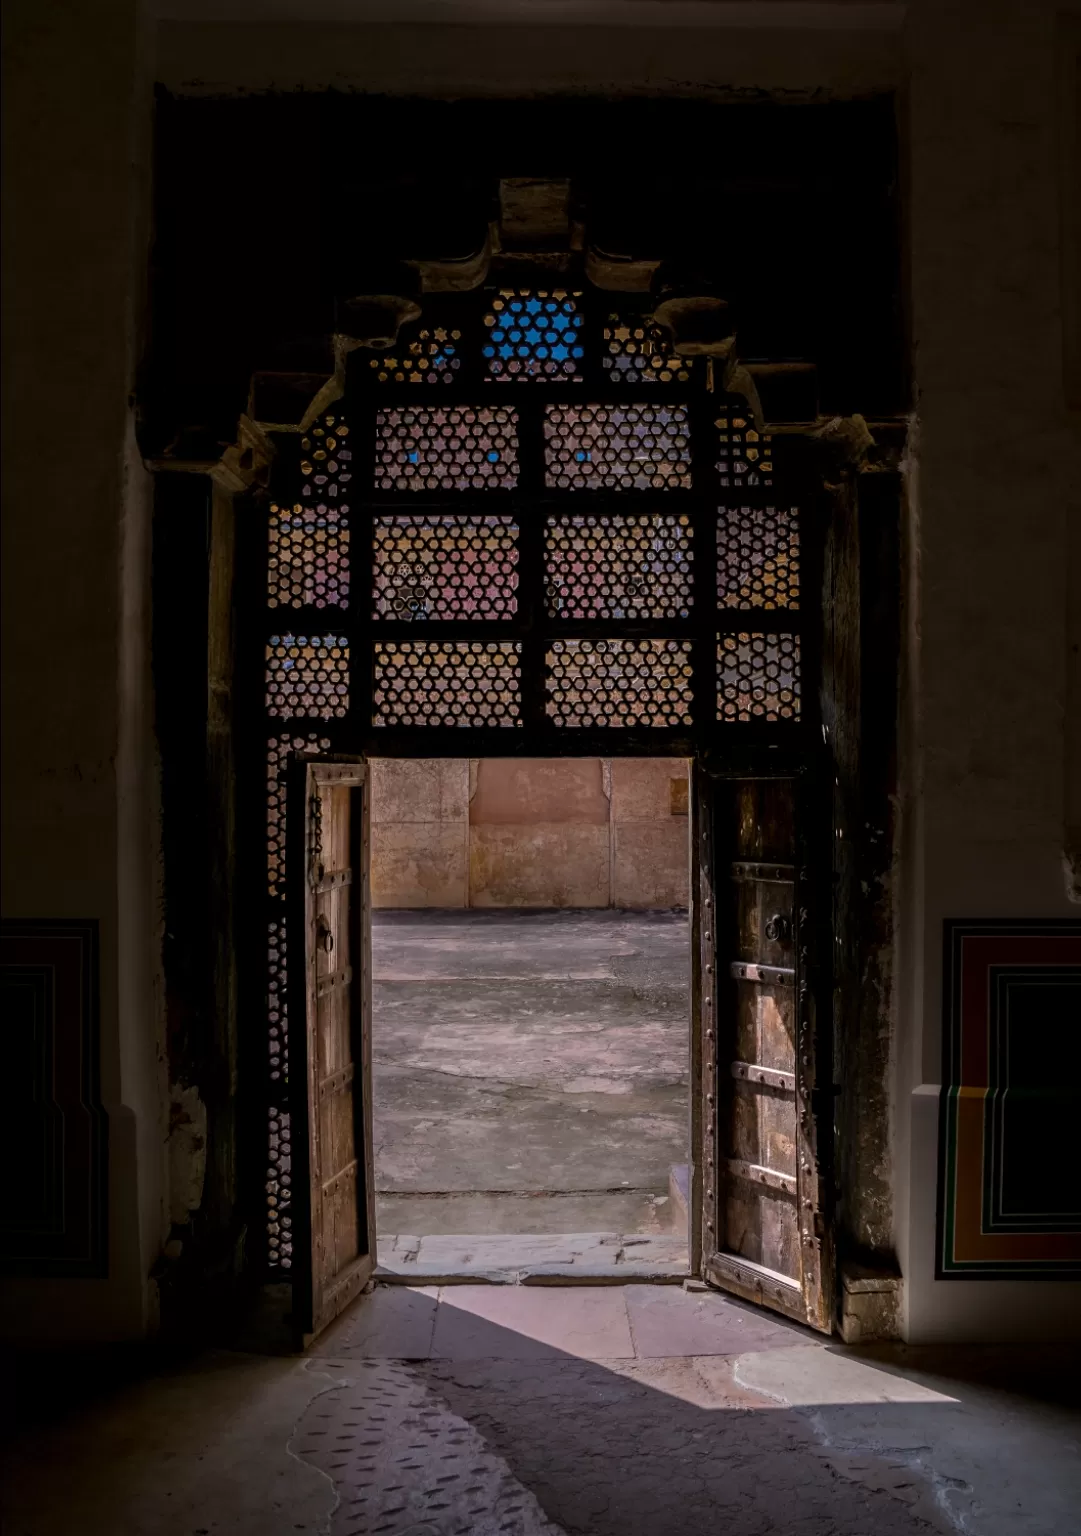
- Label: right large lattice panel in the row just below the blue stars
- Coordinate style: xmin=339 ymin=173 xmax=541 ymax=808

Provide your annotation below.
xmin=544 ymin=406 xmax=691 ymax=490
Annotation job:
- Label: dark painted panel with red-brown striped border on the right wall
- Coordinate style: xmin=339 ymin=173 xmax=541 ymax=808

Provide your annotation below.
xmin=935 ymin=919 xmax=1081 ymax=1279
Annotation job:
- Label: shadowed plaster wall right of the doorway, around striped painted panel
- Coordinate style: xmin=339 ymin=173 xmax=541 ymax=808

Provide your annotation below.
xmin=895 ymin=0 xmax=1081 ymax=1339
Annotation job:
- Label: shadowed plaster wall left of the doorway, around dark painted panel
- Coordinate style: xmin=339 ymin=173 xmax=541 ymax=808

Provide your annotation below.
xmin=0 ymin=0 xmax=167 ymax=1341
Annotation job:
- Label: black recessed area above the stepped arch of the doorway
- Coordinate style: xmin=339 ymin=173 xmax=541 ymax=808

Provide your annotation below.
xmin=140 ymin=92 xmax=907 ymax=456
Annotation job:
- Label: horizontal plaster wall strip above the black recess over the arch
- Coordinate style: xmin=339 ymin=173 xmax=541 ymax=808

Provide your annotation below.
xmin=157 ymin=13 xmax=906 ymax=97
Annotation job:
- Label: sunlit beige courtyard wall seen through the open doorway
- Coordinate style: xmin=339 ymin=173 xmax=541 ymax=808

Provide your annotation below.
xmin=372 ymin=757 xmax=688 ymax=909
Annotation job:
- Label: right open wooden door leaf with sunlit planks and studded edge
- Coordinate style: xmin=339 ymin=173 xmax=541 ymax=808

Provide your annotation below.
xmin=694 ymin=763 xmax=832 ymax=1332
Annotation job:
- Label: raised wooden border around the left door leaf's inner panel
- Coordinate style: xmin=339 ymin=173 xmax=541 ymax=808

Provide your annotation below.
xmin=287 ymin=753 xmax=376 ymax=1349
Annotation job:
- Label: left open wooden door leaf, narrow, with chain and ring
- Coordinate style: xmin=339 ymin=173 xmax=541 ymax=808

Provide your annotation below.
xmin=290 ymin=759 xmax=375 ymax=1346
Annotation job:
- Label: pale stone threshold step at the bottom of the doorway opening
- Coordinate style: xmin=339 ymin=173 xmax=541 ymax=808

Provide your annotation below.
xmin=375 ymin=1232 xmax=691 ymax=1286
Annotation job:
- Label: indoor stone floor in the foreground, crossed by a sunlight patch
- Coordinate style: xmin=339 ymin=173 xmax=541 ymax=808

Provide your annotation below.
xmin=0 ymin=1286 xmax=1081 ymax=1536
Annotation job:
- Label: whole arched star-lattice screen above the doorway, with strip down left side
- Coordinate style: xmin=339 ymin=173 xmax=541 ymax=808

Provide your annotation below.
xmin=248 ymin=287 xmax=809 ymax=1272
